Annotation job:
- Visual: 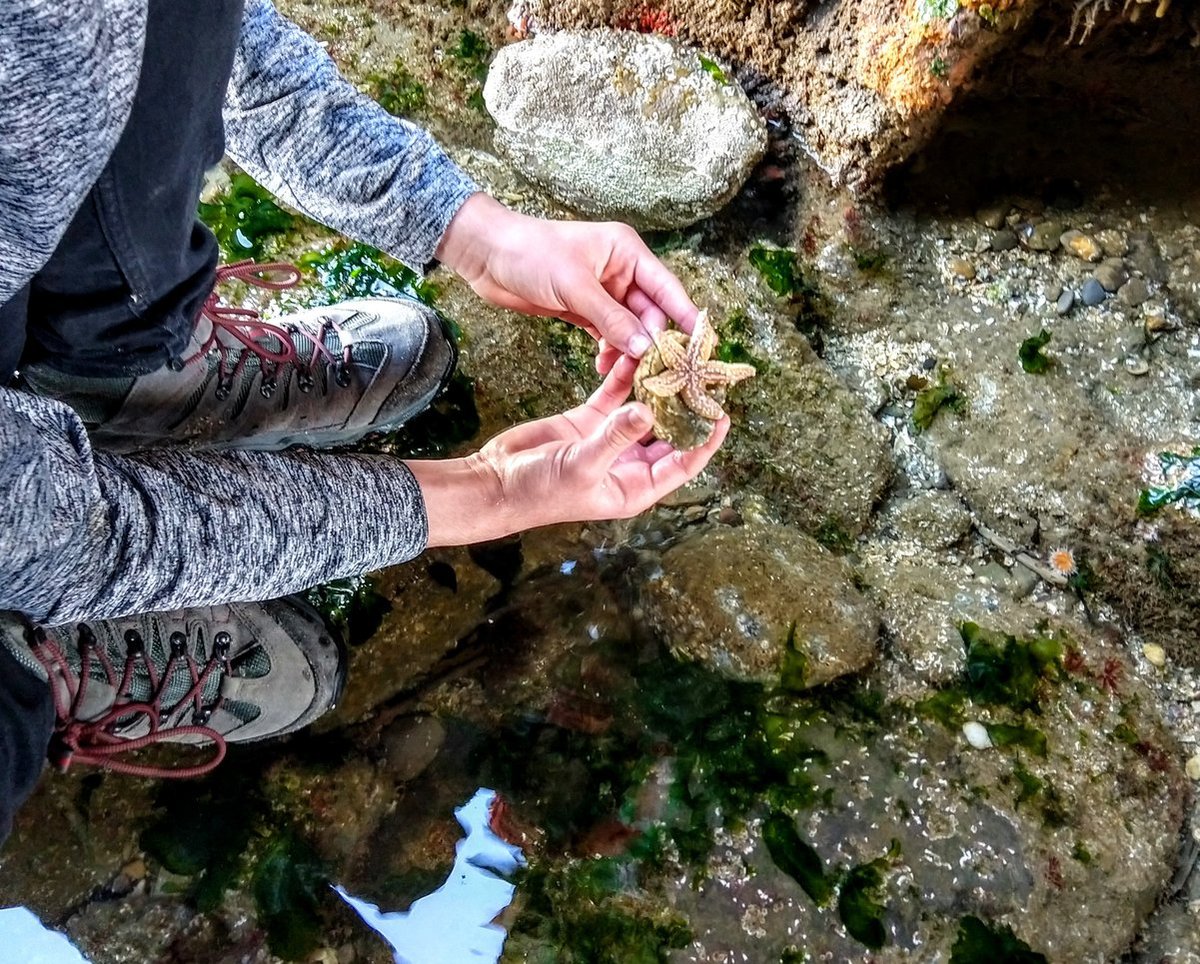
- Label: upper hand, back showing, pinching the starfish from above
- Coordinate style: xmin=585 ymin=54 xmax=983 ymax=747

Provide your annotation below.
xmin=437 ymin=193 xmax=697 ymax=372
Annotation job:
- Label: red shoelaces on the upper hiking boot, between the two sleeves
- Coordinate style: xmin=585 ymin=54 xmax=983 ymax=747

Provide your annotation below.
xmin=186 ymin=261 xmax=353 ymax=399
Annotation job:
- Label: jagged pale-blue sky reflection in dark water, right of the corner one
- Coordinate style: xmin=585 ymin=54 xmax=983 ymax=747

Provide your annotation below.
xmin=335 ymin=788 xmax=524 ymax=964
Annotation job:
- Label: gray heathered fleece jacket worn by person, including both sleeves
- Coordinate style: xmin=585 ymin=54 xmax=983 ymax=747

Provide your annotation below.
xmin=0 ymin=0 xmax=478 ymax=623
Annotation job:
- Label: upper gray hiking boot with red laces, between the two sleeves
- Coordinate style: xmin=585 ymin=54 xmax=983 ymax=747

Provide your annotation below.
xmin=23 ymin=262 xmax=456 ymax=453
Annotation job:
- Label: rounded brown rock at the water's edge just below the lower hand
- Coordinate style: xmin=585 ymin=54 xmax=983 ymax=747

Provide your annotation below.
xmin=642 ymin=526 xmax=878 ymax=689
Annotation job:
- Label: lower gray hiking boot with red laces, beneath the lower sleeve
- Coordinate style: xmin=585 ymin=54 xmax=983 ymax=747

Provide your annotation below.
xmin=0 ymin=597 xmax=346 ymax=777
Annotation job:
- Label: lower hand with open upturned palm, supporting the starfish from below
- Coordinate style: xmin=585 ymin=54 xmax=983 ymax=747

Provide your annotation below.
xmin=408 ymin=357 xmax=730 ymax=546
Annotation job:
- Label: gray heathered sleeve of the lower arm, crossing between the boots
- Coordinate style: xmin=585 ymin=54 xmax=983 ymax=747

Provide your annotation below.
xmin=0 ymin=389 xmax=427 ymax=624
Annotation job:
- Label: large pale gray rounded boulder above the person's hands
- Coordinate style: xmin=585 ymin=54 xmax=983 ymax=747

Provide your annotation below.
xmin=484 ymin=30 xmax=767 ymax=228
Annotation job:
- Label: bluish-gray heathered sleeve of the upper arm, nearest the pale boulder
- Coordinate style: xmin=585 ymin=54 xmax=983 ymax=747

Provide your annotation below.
xmin=224 ymin=0 xmax=479 ymax=271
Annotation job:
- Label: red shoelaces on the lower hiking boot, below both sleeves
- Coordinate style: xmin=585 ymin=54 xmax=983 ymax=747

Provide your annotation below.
xmin=26 ymin=623 xmax=229 ymax=779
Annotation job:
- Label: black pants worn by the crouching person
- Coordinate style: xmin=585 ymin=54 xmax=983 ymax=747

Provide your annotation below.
xmin=0 ymin=0 xmax=242 ymax=842
